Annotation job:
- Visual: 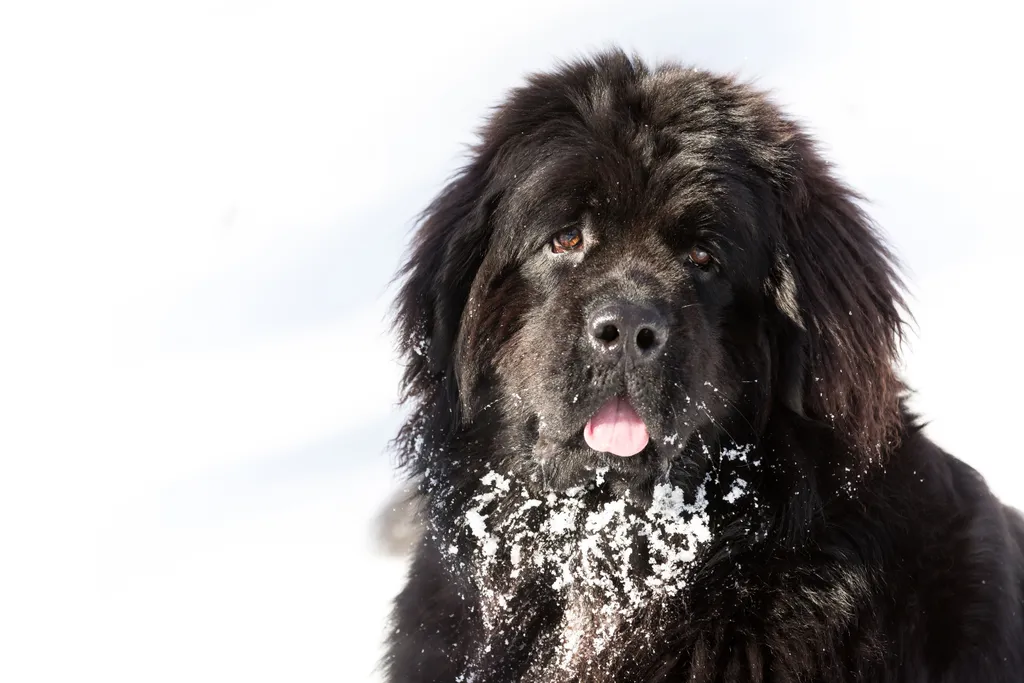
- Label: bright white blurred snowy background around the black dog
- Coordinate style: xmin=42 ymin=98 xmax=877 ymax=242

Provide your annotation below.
xmin=0 ymin=0 xmax=1024 ymax=682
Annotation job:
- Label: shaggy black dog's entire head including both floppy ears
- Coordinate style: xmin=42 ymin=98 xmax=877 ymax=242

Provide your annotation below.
xmin=397 ymin=52 xmax=902 ymax=497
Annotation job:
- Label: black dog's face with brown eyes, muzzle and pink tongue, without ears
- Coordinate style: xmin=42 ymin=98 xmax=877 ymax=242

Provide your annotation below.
xmin=458 ymin=147 xmax=778 ymax=486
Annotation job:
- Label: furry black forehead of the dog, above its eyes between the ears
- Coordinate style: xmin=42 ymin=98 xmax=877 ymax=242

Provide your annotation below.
xmin=490 ymin=69 xmax=791 ymax=259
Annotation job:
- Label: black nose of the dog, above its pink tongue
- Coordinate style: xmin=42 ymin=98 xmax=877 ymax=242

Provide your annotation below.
xmin=587 ymin=301 xmax=668 ymax=360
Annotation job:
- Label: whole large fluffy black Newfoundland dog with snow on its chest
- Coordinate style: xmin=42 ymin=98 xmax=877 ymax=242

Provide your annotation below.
xmin=384 ymin=51 xmax=1024 ymax=683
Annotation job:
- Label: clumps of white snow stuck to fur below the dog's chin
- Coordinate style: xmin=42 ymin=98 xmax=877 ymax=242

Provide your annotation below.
xmin=464 ymin=471 xmax=741 ymax=680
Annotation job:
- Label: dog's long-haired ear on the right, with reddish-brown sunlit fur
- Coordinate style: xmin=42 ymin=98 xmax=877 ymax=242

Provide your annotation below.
xmin=774 ymin=135 xmax=905 ymax=453
